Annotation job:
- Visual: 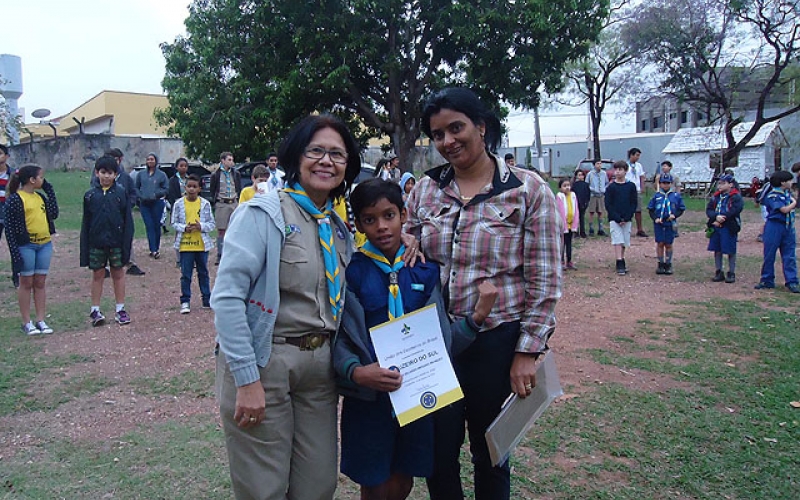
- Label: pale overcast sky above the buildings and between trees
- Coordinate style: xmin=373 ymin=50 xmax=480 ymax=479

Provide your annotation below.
xmin=0 ymin=0 xmax=635 ymax=146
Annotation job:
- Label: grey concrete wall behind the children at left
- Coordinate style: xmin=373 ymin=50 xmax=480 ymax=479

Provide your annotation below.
xmin=9 ymin=134 xmax=184 ymax=171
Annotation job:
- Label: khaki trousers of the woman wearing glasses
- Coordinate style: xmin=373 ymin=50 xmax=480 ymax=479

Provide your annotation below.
xmin=216 ymin=342 xmax=339 ymax=500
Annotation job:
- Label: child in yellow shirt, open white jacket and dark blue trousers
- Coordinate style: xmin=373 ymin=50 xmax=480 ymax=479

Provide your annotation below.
xmin=172 ymin=174 xmax=216 ymax=314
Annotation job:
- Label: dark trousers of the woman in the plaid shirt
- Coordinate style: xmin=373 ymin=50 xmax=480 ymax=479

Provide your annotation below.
xmin=427 ymin=322 xmax=520 ymax=500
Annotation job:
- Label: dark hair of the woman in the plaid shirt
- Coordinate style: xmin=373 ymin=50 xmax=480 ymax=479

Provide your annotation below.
xmin=422 ymin=87 xmax=501 ymax=153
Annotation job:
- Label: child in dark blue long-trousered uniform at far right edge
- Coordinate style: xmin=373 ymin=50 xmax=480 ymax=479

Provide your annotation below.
xmin=755 ymin=170 xmax=800 ymax=293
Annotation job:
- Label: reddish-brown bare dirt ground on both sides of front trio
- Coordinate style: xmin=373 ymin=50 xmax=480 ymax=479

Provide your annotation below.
xmin=0 ymin=209 xmax=778 ymax=456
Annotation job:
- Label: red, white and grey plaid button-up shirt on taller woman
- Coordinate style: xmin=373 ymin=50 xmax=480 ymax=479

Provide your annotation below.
xmin=405 ymin=157 xmax=561 ymax=353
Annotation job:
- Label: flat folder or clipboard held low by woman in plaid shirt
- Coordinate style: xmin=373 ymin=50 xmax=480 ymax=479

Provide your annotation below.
xmin=485 ymin=352 xmax=564 ymax=466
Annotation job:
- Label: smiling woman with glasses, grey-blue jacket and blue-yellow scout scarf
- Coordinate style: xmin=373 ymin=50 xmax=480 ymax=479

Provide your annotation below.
xmin=211 ymin=115 xmax=361 ymax=500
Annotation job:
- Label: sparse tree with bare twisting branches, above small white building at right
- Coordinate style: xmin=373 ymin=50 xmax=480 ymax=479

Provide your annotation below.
xmin=624 ymin=0 xmax=800 ymax=168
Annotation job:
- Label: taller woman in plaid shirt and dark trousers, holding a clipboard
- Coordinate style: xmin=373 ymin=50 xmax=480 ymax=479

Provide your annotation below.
xmin=406 ymin=88 xmax=561 ymax=500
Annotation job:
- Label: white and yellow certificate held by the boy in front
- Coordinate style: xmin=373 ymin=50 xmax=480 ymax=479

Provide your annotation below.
xmin=370 ymin=304 xmax=464 ymax=426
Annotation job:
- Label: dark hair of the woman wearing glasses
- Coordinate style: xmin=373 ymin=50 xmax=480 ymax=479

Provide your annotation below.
xmin=278 ymin=114 xmax=361 ymax=199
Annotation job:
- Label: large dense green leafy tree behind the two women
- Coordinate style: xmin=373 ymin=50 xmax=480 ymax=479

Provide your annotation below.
xmin=158 ymin=0 xmax=608 ymax=165
